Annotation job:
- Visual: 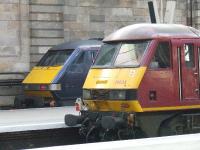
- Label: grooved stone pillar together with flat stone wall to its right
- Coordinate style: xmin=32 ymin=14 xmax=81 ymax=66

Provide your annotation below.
xmin=29 ymin=0 xmax=187 ymax=68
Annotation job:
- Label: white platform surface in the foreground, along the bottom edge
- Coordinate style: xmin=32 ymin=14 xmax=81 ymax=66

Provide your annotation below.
xmin=32 ymin=134 xmax=200 ymax=150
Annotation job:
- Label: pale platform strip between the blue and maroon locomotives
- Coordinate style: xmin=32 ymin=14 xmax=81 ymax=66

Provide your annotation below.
xmin=0 ymin=106 xmax=78 ymax=133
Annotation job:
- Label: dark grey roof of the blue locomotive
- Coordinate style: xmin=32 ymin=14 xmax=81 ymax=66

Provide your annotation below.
xmin=50 ymin=40 xmax=102 ymax=50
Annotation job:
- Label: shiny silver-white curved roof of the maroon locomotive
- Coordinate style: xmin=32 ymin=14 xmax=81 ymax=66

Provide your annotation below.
xmin=103 ymin=23 xmax=200 ymax=42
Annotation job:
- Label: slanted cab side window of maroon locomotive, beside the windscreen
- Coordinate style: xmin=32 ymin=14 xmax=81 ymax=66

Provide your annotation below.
xmin=149 ymin=42 xmax=170 ymax=69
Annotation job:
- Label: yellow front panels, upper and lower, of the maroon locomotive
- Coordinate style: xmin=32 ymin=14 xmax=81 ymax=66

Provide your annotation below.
xmin=83 ymin=67 xmax=146 ymax=112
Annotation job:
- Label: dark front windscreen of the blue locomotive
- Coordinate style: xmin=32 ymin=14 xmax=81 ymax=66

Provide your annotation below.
xmin=37 ymin=50 xmax=73 ymax=66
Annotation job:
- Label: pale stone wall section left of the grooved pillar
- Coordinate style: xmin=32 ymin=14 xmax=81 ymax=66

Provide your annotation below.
xmin=0 ymin=0 xmax=30 ymax=73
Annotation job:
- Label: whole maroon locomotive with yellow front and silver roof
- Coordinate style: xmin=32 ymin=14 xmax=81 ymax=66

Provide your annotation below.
xmin=65 ymin=24 xmax=200 ymax=140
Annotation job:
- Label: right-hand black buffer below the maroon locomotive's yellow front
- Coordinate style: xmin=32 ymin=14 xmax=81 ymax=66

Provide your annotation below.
xmin=101 ymin=116 xmax=126 ymax=129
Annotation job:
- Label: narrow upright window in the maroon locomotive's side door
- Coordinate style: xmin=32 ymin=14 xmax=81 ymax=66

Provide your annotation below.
xmin=184 ymin=44 xmax=194 ymax=68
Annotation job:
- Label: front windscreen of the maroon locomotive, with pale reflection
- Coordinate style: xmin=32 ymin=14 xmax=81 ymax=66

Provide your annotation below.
xmin=93 ymin=40 xmax=150 ymax=67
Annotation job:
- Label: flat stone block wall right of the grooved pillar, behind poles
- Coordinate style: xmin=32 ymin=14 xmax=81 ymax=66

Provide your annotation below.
xmin=63 ymin=0 xmax=187 ymax=41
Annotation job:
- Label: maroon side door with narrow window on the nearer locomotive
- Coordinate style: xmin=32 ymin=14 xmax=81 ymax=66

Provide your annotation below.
xmin=179 ymin=39 xmax=199 ymax=100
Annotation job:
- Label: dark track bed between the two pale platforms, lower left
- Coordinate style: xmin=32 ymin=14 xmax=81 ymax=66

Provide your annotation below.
xmin=0 ymin=128 xmax=84 ymax=150
